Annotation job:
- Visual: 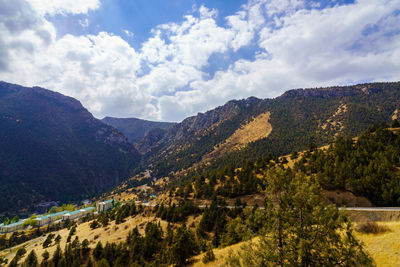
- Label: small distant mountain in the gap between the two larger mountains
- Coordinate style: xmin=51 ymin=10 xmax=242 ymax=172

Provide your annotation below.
xmin=101 ymin=117 xmax=176 ymax=147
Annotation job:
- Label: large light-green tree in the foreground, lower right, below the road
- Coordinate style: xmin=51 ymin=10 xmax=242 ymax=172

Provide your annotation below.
xmin=228 ymin=168 xmax=372 ymax=266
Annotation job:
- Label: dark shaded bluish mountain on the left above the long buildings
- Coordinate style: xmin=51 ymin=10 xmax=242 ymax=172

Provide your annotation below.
xmin=0 ymin=82 xmax=140 ymax=212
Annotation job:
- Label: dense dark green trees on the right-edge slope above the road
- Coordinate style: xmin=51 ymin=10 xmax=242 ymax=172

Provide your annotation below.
xmin=295 ymin=124 xmax=400 ymax=206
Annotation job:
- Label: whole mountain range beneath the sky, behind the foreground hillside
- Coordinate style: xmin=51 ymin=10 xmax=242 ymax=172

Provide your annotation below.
xmin=0 ymin=82 xmax=400 ymax=215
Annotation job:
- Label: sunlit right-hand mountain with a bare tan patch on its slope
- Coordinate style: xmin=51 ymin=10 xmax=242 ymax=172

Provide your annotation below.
xmin=144 ymin=82 xmax=400 ymax=177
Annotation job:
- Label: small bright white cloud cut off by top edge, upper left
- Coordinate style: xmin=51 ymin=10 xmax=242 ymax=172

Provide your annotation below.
xmin=27 ymin=0 xmax=100 ymax=15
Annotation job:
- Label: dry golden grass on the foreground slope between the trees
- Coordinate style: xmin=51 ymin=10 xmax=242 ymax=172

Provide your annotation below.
xmin=0 ymin=215 xmax=400 ymax=267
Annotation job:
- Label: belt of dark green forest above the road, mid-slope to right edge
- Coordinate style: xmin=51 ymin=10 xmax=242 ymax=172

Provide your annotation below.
xmin=170 ymin=120 xmax=400 ymax=206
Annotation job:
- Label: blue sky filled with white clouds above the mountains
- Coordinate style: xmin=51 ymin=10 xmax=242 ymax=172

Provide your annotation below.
xmin=0 ymin=0 xmax=400 ymax=121
